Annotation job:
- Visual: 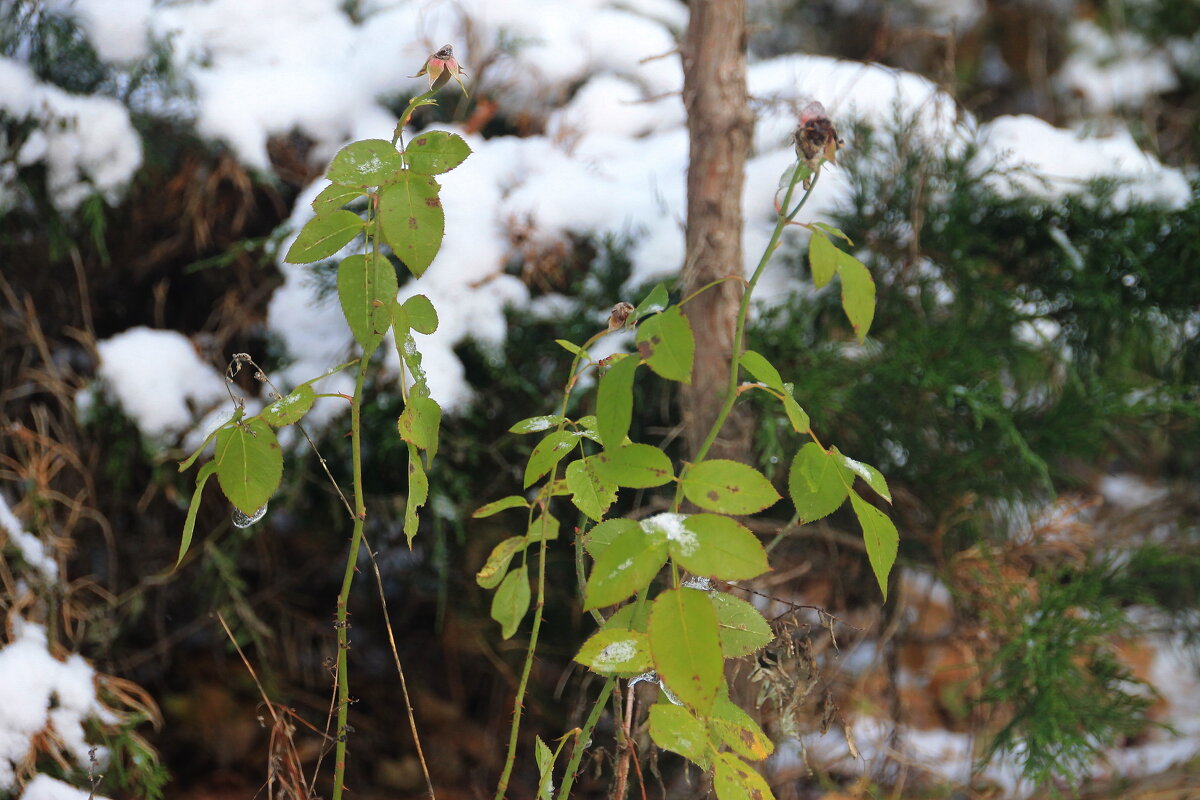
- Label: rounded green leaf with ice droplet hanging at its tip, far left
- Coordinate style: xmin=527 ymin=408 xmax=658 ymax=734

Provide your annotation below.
xmin=212 ymin=419 xmax=283 ymax=517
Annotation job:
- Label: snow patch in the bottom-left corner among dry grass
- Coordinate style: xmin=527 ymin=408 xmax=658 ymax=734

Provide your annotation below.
xmin=0 ymin=616 xmax=115 ymax=798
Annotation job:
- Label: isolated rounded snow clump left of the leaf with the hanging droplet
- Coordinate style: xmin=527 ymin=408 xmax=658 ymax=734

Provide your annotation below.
xmin=96 ymin=326 xmax=228 ymax=439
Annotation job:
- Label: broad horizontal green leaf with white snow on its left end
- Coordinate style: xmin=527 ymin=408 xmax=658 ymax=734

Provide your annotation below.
xmin=672 ymin=513 xmax=770 ymax=581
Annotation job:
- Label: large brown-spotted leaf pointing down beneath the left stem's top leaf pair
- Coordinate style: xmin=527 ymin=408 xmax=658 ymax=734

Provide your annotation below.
xmin=379 ymin=170 xmax=445 ymax=277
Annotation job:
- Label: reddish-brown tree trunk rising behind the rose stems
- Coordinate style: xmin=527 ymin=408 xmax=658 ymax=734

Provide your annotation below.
xmin=683 ymin=0 xmax=752 ymax=458
